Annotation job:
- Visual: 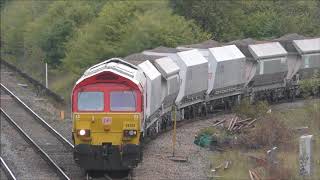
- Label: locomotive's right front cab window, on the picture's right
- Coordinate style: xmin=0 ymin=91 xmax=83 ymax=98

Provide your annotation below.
xmin=110 ymin=91 xmax=137 ymax=111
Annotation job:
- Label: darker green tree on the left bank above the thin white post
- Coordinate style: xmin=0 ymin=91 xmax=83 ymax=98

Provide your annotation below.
xmin=25 ymin=1 xmax=100 ymax=67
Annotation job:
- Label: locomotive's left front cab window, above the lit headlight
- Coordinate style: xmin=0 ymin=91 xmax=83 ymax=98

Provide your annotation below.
xmin=78 ymin=92 xmax=104 ymax=111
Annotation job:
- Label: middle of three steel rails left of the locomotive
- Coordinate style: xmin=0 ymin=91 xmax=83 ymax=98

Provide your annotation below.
xmin=0 ymin=108 xmax=70 ymax=180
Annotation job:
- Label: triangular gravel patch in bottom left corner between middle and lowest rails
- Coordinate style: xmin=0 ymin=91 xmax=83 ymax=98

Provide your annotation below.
xmin=1 ymin=115 xmax=59 ymax=179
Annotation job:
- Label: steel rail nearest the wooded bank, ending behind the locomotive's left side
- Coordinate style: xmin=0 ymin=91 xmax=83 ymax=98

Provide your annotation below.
xmin=0 ymin=83 xmax=74 ymax=149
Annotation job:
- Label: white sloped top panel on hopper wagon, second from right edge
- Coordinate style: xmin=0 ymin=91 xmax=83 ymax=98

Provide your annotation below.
xmin=249 ymin=42 xmax=287 ymax=59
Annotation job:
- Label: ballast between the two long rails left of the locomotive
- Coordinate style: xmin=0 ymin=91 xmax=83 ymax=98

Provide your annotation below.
xmin=1 ymin=91 xmax=82 ymax=179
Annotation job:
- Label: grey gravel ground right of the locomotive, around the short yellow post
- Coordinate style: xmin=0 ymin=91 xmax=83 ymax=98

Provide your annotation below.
xmin=134 ymin=115 xmax=230 ymax=180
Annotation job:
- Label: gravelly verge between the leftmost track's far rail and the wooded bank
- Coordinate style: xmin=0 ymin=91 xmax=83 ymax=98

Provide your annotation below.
xmin=0 ymin=64 xmax=72 ymax=142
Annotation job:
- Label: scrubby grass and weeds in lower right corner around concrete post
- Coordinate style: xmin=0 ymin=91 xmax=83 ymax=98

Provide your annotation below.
xmin=198 ymin=99 xmax=320 ymax=179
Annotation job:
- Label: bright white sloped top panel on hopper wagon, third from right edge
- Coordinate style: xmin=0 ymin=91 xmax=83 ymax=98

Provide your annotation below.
xmin=209 ymin=45 xmax=245 ymax=62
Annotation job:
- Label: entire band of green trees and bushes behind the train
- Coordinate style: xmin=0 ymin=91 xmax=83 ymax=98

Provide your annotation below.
xmin=1 ymin=0 xmax=320 ymax=99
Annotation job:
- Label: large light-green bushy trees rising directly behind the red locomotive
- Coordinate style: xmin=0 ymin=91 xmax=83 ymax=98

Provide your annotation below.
xmin=64 ymin=1 xmax=207 ymax=73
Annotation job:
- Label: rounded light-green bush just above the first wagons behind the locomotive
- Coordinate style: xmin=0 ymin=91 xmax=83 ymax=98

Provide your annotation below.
xmin=120 ymin=9 xmax=210 ymax=55
